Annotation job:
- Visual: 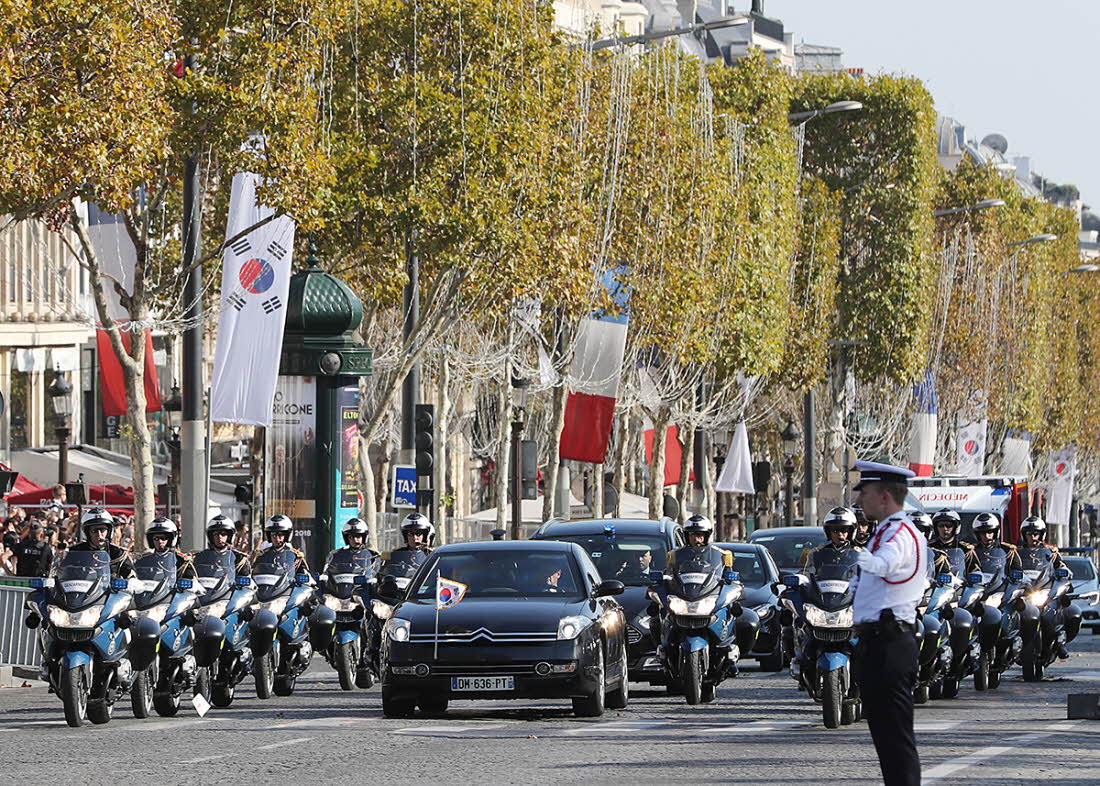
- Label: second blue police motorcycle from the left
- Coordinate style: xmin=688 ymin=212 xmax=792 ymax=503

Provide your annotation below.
xmin=129 ymin=552 xmax=198 ymax=718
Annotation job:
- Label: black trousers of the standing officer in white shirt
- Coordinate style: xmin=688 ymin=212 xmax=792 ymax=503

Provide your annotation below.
xmin=855 ymin=629 xmax=921 ymax=786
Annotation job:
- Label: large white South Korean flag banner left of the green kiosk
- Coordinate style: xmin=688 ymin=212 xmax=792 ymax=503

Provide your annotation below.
xmin=210 ymin=137 xmax=295 ymax=425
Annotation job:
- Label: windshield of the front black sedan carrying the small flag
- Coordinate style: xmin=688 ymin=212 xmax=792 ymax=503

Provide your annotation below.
xmin=416 ymin=550 xmax=584 ymax=600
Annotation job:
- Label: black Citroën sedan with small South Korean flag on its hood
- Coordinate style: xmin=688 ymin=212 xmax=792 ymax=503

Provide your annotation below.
xmin=381 ymin=541 xmax=629 ymax=718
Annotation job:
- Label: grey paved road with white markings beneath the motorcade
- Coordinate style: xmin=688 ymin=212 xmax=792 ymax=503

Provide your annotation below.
xmin=0 ymin=632 xmax=1100 ymax=786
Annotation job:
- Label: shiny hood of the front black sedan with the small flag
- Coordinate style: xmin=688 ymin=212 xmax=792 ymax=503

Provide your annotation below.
xmin=394 ymin=597 xmax=589 ymax=633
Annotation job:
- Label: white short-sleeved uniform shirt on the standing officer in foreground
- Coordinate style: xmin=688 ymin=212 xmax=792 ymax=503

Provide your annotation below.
xmin=853 ymin=512 xmax=928 ymax=623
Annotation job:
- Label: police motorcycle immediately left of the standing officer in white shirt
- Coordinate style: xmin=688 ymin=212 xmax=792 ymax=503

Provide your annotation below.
xmin=782 ymin=549 xmax=862 ymax=729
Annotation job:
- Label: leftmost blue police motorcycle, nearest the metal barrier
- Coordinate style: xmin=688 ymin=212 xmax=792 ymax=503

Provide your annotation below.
xmin=26 ymin=551 xmax=133 ymax=727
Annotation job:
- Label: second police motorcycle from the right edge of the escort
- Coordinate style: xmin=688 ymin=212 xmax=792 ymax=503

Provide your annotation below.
xmin=959 ymin=546 xmax=1038 ymax=690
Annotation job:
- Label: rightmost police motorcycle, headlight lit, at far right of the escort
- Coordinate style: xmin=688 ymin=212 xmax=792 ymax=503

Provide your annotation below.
xmin=1019 ymin=538 xmax=1081 ymax=683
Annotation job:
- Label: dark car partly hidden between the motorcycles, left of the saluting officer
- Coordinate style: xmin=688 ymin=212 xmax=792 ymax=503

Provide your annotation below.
xmin=715 ymin=543 xmax=790 ymax=672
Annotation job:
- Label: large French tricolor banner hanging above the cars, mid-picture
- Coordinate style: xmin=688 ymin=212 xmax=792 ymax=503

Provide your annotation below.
xmin=561 ymin=270 xmax=628 ymax=464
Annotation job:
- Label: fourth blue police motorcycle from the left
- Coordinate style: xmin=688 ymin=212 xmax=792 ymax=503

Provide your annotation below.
xmin=249 ymin=549 xmax=314 ymax=699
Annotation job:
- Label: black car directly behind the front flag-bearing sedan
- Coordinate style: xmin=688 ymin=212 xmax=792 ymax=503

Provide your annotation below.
xmin=531 ymin=519 xmax=684 ymax=685
